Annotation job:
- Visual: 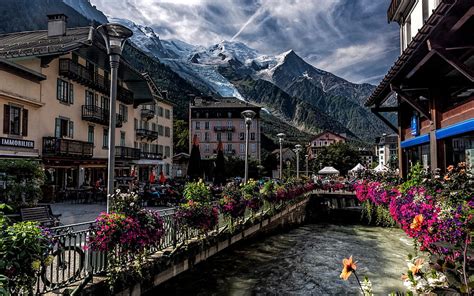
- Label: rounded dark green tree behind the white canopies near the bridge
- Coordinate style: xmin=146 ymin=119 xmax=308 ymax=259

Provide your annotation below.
xmin=313 ymin=143 xmax=361 ymax=175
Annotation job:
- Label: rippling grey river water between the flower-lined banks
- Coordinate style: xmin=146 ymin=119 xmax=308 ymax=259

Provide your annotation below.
xmin=156 ymin=224 xmax=413 ymax=295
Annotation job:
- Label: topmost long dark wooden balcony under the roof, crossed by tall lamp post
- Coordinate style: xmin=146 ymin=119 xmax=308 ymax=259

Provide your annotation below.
xmin=59 ymin=59 xmax=133 ymax=105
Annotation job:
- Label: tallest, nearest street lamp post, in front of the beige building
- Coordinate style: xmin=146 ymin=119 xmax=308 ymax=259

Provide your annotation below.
xmin=97 ymin=23 xmax=133 ymax=213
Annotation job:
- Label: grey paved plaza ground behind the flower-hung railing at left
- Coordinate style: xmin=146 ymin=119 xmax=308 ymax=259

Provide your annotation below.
xmin=51 ymin=203 xmax=173 ymax=225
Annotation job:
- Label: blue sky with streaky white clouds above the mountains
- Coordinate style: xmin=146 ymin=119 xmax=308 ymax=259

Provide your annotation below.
xmin=91 ymin=0 xmax=399 ymax=84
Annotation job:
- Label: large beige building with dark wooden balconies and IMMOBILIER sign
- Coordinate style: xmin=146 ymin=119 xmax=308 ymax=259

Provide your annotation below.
xmin=0 ymin=15 xmax=173 ymax=198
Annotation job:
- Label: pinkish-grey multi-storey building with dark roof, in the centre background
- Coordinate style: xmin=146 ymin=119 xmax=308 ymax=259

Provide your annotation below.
xmin=189 ymin=97 xmax=261 ymax=161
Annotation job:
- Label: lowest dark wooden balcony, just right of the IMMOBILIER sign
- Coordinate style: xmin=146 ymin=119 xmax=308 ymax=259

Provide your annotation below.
xmin=43 ymin=137 xmax=94 ymax=158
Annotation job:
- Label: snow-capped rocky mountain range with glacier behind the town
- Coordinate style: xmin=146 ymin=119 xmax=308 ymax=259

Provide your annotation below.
xmin=2 ymin=0 xmax=389 ymax=146
